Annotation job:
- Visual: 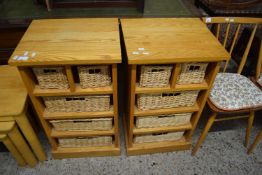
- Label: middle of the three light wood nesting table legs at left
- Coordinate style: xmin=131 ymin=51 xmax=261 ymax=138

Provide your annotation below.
xmin=8 ymin=126 xmax=37 ymax=167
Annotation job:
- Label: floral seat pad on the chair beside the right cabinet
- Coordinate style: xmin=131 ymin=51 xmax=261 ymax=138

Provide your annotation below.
xmin=209 ymin=73 xmax=262 ymax=110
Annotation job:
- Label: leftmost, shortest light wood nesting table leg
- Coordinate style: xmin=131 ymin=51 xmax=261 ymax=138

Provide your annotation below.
xmin=1 ymin=136 xmax=26 ymax=166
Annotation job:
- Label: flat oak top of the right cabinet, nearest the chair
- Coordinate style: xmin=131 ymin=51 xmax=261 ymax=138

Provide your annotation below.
xmin=121 ymin=18 xmax=230 ymax=64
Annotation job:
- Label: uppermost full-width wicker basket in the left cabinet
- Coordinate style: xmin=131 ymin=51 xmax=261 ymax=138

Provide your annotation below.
xmin=43 ymin=95 xmax=110 ymax=112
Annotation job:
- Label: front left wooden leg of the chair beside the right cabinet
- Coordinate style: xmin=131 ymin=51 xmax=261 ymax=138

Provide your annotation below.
xmin=192 ymin=113 xmax=217 ymax=156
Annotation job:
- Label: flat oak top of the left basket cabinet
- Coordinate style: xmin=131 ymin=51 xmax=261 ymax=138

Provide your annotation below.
xmin=9 ymin=18 xmax=121 ymax=66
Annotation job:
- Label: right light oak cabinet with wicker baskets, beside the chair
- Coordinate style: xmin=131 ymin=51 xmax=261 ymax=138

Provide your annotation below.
xmin=121 ymin=18 xmax=229 ymax=155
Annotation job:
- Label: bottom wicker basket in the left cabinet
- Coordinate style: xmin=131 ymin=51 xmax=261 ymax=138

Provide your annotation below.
xmin=58 ymin=136 xmax=113 ymax=147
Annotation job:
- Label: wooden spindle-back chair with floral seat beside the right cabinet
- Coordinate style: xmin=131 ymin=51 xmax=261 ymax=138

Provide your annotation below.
xmin=192 ymin=17 xmax=262 ymax=155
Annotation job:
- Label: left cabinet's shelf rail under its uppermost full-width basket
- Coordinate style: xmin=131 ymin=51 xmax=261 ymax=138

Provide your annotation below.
xmin=43 ymin=107 xmax=114 ymax=120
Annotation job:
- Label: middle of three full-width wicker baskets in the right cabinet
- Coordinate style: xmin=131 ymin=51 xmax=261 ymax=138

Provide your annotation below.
xmin=136 ymin=113 xmax=192 ymax=128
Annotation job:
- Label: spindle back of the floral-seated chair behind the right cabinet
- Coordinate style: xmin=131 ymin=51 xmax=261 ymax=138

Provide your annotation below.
xmin=202 ymin=17 xmax=262 ymax=74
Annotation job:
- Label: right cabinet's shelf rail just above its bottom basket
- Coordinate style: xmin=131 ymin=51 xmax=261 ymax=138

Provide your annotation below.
xmin=133 ymin=123 xmax=192 ymax=135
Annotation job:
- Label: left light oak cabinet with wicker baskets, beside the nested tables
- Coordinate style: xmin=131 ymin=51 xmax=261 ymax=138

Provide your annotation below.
xmin=9 ymin=18 xmax=121 ymax=159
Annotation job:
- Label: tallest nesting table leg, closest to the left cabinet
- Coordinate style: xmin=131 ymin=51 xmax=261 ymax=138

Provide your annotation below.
xmin=15 ymin=112 xmax=47 ymax=161
